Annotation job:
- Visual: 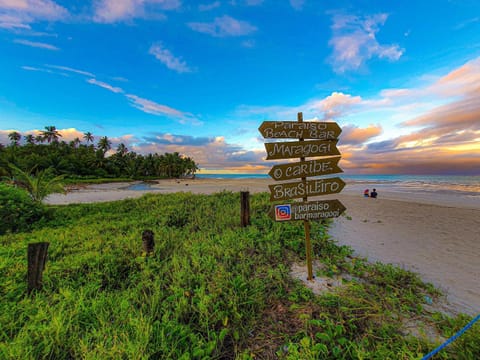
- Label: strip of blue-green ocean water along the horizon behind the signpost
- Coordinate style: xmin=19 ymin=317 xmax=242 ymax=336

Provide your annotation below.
xmin=197 ymin=173 xmax=480 ymax=196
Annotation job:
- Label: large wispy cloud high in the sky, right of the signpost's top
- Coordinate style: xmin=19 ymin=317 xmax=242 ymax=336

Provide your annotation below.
xmin=329 ymin=14 xmax=405 ymax=73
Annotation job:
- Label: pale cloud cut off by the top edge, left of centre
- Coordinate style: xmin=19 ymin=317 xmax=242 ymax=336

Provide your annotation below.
xmin=93 ymin=0 xmax=181 ymax=23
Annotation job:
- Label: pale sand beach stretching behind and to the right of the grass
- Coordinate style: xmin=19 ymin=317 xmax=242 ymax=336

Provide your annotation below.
xmin=46 ymin=179 xmax=480 ymax=315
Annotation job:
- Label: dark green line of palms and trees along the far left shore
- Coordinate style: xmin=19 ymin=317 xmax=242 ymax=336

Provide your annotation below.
xmin=0 ymin=126 xmax=198 ymax=179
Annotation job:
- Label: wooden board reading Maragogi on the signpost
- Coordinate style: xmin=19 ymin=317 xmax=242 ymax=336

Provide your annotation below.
xmin=265 ymin=140 xmax=340 ymax=160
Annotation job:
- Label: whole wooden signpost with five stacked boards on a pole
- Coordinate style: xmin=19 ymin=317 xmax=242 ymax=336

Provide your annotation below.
xmin=258 ymin=113 xmax=345 ymax=281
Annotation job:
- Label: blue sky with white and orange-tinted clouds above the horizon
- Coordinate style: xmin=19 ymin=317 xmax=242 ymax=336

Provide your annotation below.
xmin=0 ymin=0 xmax=480 ymax=174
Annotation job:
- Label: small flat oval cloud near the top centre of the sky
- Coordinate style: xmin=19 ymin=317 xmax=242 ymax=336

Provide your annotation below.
xmin=188 ymin=15 xmax=257 ymax=37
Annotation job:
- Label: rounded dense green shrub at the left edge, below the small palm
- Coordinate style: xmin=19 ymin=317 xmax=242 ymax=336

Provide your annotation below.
xmin=0 ymin=183 xmax=45 ymax=234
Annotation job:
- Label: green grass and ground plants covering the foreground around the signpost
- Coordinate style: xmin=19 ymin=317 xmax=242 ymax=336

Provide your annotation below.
xmin=0 ymin=192 xmax=480 ymax=359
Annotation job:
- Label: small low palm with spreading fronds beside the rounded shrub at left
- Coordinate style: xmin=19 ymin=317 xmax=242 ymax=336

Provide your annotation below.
xmin=10 ymin=164 xmax=65 ymax=202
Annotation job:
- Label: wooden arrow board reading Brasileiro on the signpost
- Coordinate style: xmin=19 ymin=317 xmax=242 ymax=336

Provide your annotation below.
xmin=268 ymin=177 xmax=345 ymax=201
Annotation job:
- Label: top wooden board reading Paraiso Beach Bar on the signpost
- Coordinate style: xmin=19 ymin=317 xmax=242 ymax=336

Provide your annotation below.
xmin=258 ymin=121 xmax=342 ymax=140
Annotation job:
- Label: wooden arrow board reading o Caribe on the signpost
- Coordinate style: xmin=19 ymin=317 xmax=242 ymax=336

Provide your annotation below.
xmin=268 ymin=156 xmax=343 ymax=181
